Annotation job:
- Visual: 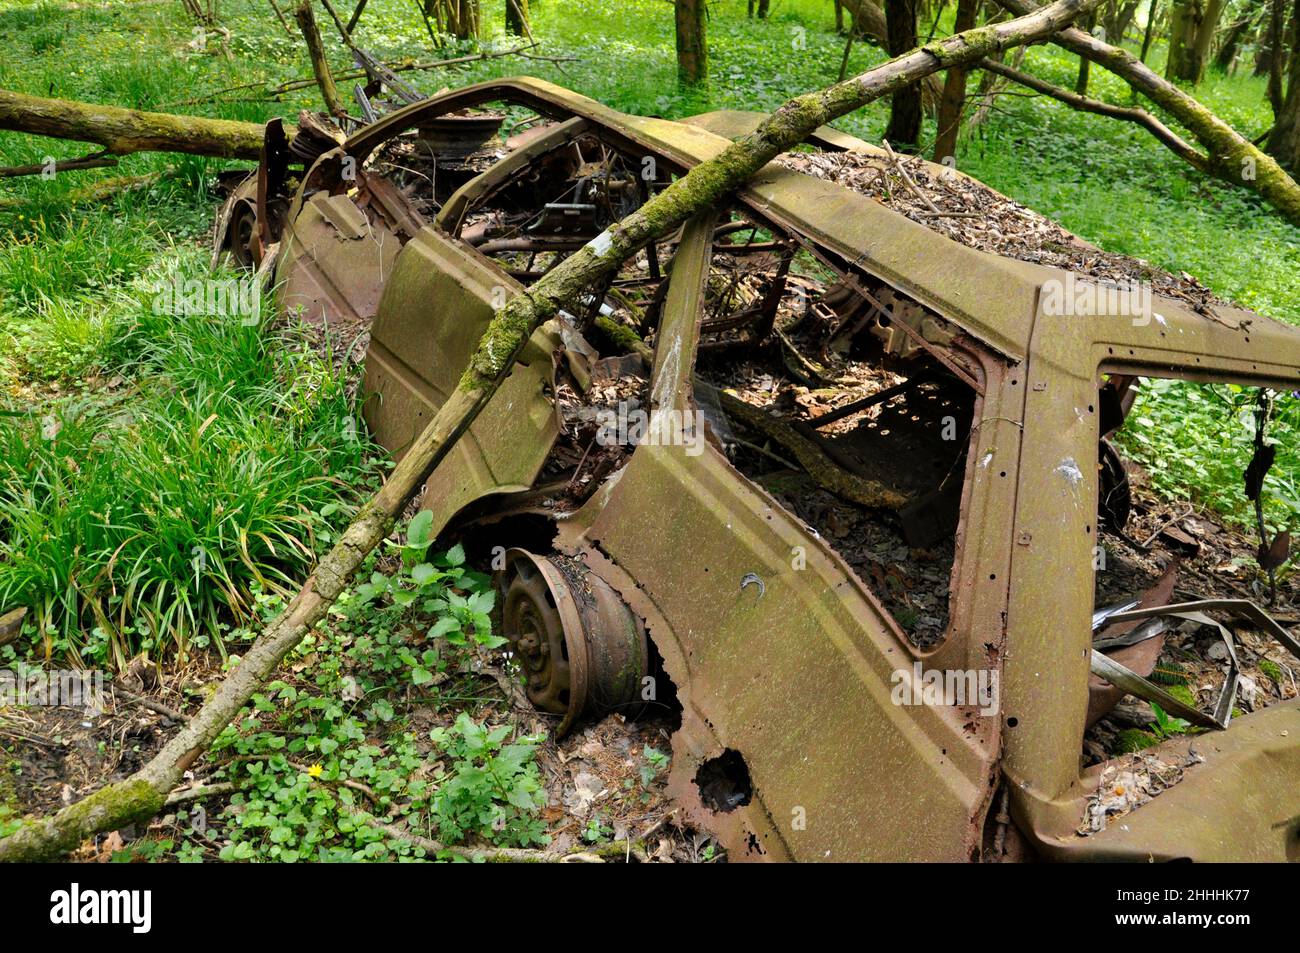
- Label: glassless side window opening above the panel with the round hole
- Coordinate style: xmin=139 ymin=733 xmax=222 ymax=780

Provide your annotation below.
xmin=697 ymin=228 xmax=976 ymax=650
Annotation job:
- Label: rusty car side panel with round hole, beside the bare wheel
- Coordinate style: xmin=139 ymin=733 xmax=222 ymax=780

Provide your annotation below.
xmin=559 ymin=446 xmax=993 ymax=861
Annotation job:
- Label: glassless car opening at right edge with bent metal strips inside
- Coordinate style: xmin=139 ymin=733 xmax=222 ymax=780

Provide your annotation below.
xmin=1083 ymin=373 xmax=1300 ymax=780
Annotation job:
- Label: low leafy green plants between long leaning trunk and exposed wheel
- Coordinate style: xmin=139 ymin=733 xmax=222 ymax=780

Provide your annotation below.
xmin=176 ymin=514 xmax=549 ymax=861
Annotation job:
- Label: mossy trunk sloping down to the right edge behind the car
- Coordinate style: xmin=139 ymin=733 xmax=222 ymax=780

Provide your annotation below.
xmin=997 ymin=0 xmax=1300 ymax=225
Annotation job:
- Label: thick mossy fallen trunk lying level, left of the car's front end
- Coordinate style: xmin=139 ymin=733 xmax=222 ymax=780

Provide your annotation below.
xmin=0 ymin=90 xmax=269 ymax=160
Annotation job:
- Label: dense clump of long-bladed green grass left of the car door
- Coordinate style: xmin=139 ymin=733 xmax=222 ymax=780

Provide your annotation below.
xmin=0 ymin=255 xmax=371 ymax=666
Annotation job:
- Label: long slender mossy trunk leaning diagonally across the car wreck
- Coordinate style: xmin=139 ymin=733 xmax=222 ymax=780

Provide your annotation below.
xmin=0 ymin=0 xmax=1100 ymax=861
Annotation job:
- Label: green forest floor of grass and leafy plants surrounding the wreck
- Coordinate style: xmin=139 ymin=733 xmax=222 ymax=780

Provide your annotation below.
xmin=0 ymin=0 xmax=1300 ymax=862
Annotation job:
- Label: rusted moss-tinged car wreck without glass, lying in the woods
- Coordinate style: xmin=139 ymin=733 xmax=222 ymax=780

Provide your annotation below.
xmin=218 ymin=78 xmax=1300 ymax=861
